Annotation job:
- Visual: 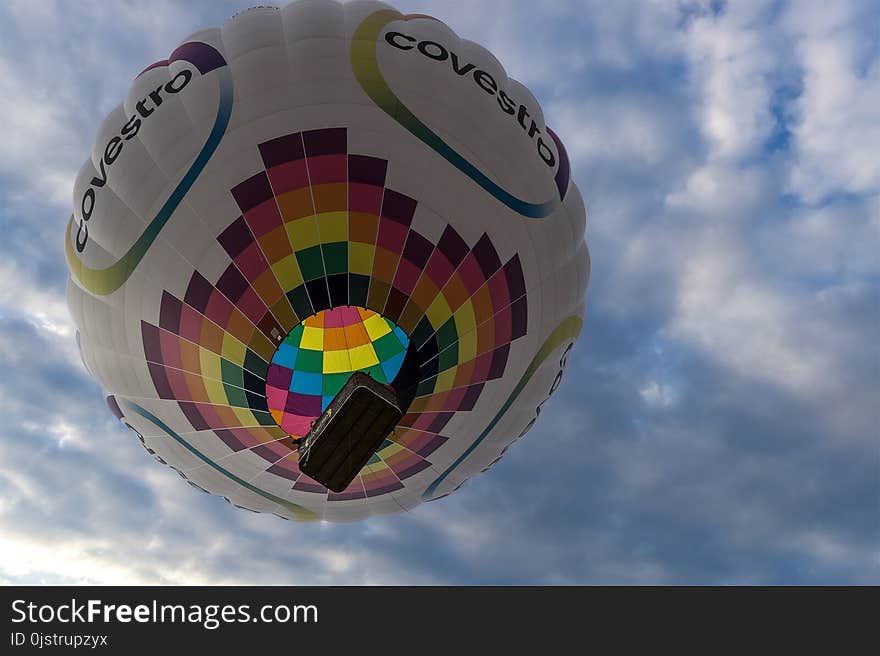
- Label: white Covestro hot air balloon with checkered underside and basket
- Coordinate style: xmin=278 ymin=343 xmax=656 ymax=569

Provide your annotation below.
xmin=65 ymin=0 xmax=589 ymax=521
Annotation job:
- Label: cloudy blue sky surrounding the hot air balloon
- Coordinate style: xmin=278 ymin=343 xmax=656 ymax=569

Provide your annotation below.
xmin=0 ymin=0 xmax=880 ymax=585
